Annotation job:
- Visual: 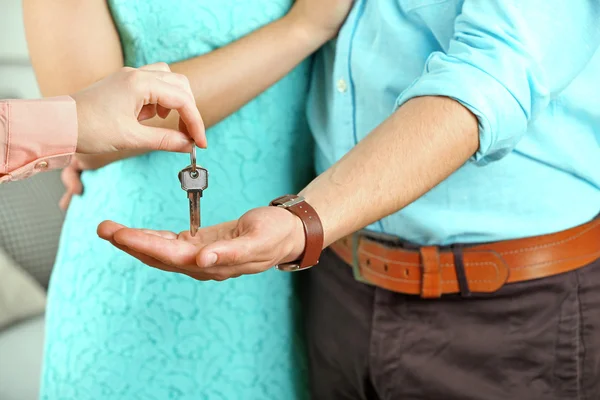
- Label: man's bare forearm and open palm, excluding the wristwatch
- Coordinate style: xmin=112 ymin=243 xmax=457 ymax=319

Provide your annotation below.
xmin=98 ymin=97 xmax=478 ymax=280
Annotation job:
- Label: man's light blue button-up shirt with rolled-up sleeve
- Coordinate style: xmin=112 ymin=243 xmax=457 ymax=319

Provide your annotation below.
xmin=308 ymin=0 xmax=600 ymax=244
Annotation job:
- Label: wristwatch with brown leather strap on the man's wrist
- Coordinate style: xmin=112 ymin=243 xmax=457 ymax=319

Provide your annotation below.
xmin=270 ymin=194 xmax=323 ymax=272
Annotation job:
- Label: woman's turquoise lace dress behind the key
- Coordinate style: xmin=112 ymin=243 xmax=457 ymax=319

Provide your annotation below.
xmin=41 ymin=0 xmax=312 ymax=400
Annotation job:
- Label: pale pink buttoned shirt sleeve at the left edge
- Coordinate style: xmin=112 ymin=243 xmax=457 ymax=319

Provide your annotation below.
xmin=0 ymin=96 xmax=77 ymax=183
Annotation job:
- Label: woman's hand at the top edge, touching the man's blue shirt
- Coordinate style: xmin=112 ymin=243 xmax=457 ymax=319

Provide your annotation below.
xmin=287 ymin=0 xmax=354 ymax=41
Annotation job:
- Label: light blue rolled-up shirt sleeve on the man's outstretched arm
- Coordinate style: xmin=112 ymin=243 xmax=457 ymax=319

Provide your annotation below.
xmin=396 ymin=0 xmax=600 ymax=165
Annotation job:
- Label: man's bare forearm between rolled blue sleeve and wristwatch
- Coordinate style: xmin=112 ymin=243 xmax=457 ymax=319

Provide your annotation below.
xmin=301 ymin=97 xmax=479 ymax=246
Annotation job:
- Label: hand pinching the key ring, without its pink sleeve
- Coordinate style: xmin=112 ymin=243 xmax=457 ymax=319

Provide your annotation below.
xmin=72 ymin=63 xmax=206 ymax=154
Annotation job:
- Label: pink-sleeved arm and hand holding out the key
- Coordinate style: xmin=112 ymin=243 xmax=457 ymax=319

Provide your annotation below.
xmin=0 ymin=64 xmax=206 ymax=183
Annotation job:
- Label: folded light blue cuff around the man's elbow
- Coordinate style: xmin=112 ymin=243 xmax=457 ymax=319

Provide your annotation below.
xmin=395 ymin=52 xmax=527 ymax=165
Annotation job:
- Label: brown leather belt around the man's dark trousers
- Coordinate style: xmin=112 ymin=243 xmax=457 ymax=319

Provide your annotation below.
xmin=330 ymin=218 xmax=600 ymax=298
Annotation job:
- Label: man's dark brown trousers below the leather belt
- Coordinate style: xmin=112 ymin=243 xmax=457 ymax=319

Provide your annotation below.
xmin=302 ymin=250 xmax=600 ymax=400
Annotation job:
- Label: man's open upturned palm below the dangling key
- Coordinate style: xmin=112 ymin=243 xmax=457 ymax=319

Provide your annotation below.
xmin=98 ymin=207 xmax=305 ymax=281
